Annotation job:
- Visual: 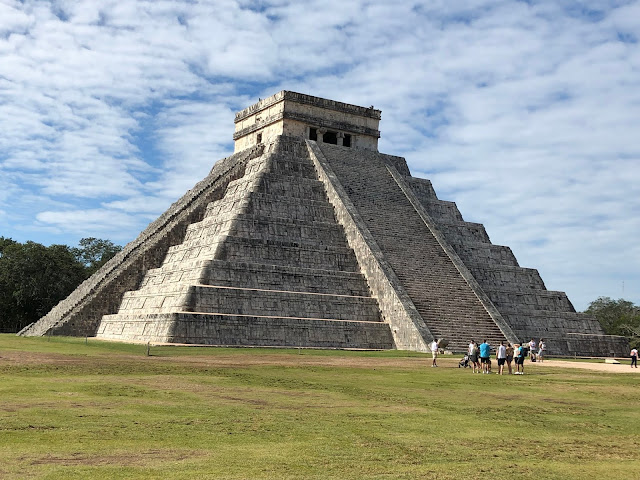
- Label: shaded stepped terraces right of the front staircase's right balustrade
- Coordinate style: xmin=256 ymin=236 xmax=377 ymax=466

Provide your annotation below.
xmin=406 ymin=177 xmax=626 ymax=356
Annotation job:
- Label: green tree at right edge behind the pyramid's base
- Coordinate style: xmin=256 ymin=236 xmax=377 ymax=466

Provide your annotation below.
xmin=585 ymin=297 xmax=640 ymax=347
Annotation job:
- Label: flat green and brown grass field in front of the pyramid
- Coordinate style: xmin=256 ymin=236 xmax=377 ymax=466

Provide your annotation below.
xmin=0 ymin=335 xmax=640 ymax=480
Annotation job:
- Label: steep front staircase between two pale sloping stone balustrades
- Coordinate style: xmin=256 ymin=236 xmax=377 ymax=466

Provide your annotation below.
xmin=319 ymin=144 xmax=506 ymax=351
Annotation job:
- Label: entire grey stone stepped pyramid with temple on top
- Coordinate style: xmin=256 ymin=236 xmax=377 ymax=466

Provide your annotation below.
xmin=20 ymin=91 xmax=627 ymax=355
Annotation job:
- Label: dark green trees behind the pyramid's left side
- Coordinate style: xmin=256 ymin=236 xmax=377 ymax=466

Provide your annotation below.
xmin=0 ymin=237 xmax=122 ymax=332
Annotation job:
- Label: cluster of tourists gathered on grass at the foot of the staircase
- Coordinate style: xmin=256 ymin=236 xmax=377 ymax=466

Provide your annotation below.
xmin=467 ymin=338 xmax=547 ymax=375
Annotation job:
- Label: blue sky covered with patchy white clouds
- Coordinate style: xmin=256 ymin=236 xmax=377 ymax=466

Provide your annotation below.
xmin=0 ymin=0 xmax=640 ymax=311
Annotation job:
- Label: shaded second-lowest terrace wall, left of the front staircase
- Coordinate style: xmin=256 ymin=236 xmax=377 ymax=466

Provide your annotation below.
xmin=189 ymin=285 xmax=381 ymax=322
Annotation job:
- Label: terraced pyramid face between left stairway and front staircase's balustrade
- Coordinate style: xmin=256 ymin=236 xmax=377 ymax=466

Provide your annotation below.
xmin=98 ymin=137 xmax=393 ymax=349
